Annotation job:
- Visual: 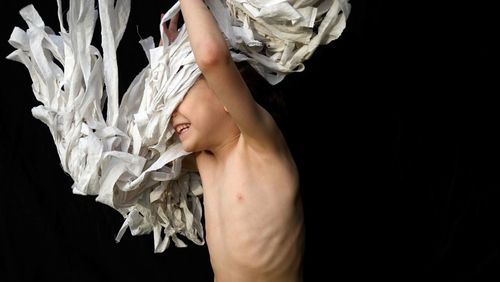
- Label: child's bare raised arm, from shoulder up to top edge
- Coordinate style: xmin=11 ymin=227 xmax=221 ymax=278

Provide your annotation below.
xmin=180 ymin=0 xmax=276 ymax=148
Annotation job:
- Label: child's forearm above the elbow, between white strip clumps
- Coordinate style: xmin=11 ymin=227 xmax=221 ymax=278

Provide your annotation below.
xmin=180 ymin=0 xmax=229 ymax=68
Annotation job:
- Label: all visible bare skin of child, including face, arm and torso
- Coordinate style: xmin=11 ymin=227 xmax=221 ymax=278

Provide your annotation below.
xmin=165 ymin=0 xmax=304 ymax=282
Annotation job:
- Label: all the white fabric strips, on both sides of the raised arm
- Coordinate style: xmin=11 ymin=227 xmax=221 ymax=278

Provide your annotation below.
xmin=7 ymin=0 xmax=350 ymax=252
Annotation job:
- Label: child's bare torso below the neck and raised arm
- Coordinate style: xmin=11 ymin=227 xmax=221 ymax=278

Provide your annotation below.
xmin=196 ymin=137 xmax=304 ymax=282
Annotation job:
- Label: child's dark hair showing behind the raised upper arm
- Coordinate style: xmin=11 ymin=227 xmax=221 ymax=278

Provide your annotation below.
xmin=236 ymin=61 xmax=286 ymax=127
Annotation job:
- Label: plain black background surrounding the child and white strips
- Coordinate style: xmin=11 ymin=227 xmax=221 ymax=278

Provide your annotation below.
xmin=0 ymin=0 xmax=500 ymax=281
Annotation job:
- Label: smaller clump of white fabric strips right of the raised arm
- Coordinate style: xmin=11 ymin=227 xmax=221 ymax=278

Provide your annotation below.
xmin=212 ymin=0 xmax=350 ymax=84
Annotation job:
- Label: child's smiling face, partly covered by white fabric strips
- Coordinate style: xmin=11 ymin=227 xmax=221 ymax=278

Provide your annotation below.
xmin=171 ymin=77 xmax=230 ymax=152
